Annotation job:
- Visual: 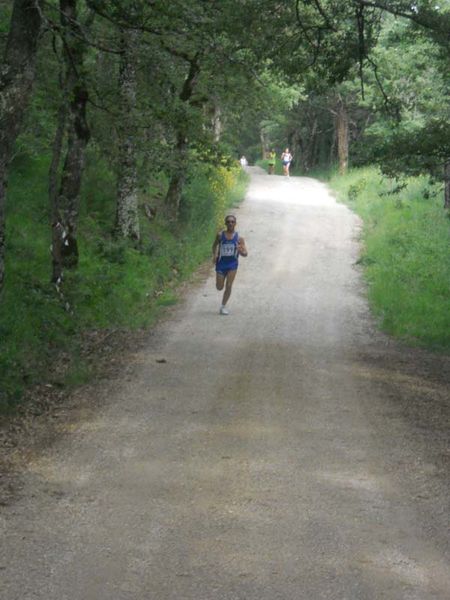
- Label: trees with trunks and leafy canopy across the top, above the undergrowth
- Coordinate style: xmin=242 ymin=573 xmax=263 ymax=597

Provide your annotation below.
xmin=0 ymin=0 xmax=450 ymax=298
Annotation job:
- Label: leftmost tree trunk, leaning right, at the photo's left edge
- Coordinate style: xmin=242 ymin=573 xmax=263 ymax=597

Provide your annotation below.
xmin=0 ymin=0 xmax=41 ymax=291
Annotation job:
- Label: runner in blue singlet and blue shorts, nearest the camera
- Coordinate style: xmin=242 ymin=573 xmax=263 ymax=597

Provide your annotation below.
xmin=212 ymin=215 xmax=247 ymax=315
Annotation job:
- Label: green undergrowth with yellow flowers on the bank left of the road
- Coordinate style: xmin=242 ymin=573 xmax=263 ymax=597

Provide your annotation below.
xmin=0 ymin=151 xmax=248 ymax=414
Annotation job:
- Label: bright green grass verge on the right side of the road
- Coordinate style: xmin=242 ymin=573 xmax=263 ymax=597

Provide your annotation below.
xmin=330 ymin=168 xmax=450 ymax=351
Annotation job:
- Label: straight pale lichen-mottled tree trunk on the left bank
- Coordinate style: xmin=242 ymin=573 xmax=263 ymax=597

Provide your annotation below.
xmin=116 ymin=29 xmax=140 ymax=240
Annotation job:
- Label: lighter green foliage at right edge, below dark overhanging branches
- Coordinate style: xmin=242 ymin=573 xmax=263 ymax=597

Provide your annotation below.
xmin=362 ymin=19 xmax=450 ymax=178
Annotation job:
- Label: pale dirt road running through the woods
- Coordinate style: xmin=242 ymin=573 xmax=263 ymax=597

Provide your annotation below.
xmin=0 ymin=169 xmax=450 ymax=600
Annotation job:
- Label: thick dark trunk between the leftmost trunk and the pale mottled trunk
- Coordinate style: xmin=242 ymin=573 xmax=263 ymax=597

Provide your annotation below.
xmin=52 ymin=0 xmax=90 ymax=282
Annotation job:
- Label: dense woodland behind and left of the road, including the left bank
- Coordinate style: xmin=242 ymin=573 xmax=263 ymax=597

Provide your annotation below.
xmin=0 ymin=0 xmax=450 ymax=406
